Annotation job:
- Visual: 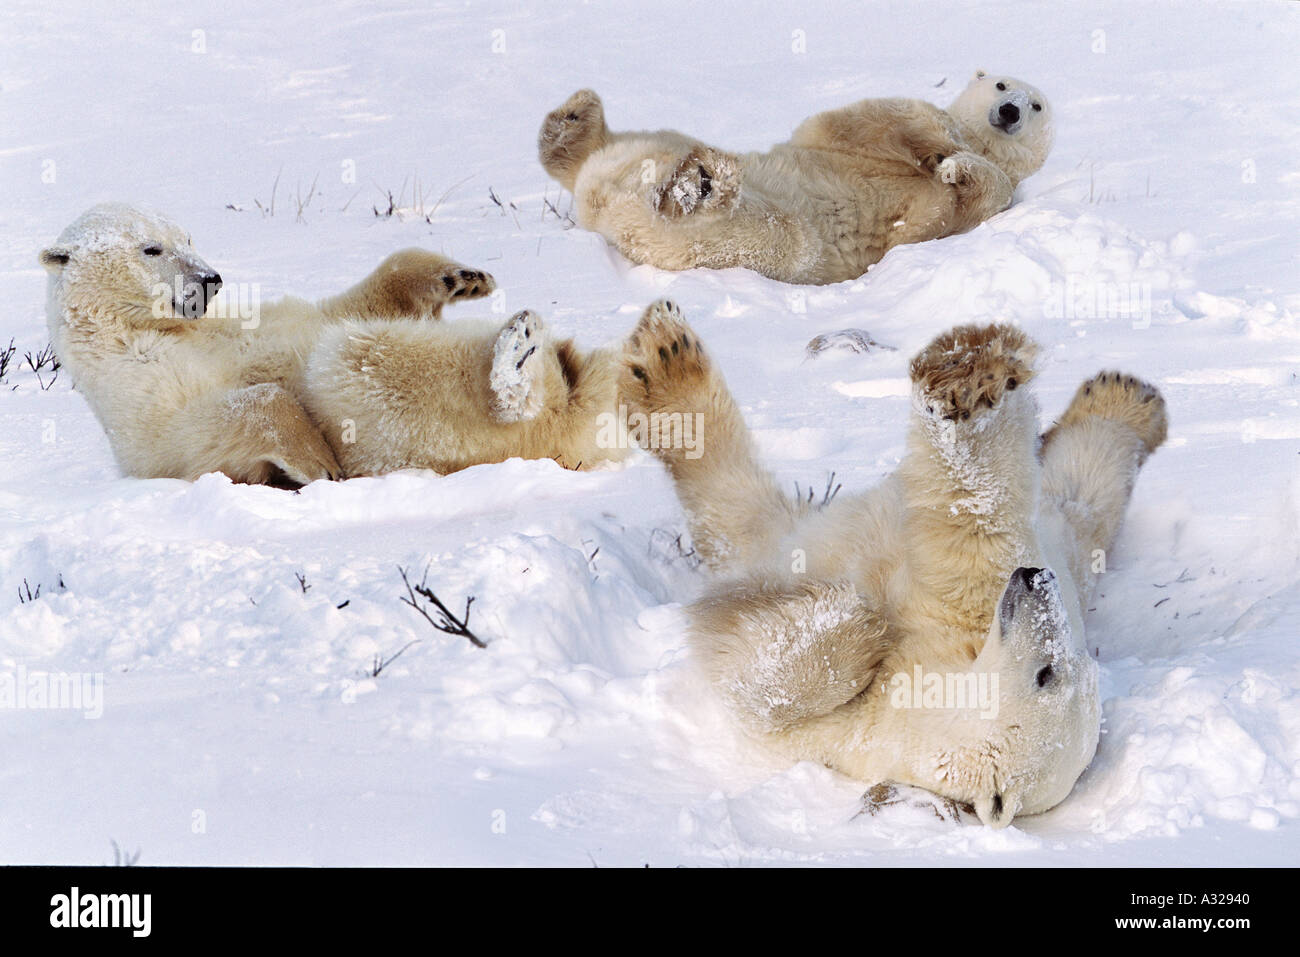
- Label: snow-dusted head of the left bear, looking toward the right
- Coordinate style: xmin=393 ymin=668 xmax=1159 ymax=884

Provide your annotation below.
xmin=40 ymin=203 xmax=221 ymax=326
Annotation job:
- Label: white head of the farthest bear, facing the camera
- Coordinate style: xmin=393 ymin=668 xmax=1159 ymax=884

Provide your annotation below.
xmin=948 ymin=70 xmax=1054 ymax=186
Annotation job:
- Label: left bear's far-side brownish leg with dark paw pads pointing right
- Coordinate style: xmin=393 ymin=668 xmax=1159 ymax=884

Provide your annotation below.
xmin=320 ymin=248 xmax=497 ymax=319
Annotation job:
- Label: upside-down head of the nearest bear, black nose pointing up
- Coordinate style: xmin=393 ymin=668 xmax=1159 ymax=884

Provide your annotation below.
xmin=940 ymin=568 xmax=1101 ymax=827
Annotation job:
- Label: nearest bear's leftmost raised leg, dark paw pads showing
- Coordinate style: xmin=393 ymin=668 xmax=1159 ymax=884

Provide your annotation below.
xmin=619 ymin=300 xmax=797 ymax=568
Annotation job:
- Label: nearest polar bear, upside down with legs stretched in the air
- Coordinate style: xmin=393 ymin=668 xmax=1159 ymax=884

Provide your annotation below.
xmin=620 ymin=306 xmax=1167 ymax=827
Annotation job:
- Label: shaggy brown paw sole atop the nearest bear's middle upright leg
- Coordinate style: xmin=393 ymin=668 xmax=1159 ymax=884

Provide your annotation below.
xmin=911 ymin=322 xmax=1037 ymax=421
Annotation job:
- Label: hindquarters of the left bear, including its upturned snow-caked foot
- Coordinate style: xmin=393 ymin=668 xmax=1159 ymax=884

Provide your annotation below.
xmin=302 ymin=311 xmax=628 ymax=476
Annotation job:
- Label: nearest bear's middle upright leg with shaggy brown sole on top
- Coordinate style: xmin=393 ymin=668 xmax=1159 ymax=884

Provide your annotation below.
xmin=898 ymin=324 xmax=1039 ymax=620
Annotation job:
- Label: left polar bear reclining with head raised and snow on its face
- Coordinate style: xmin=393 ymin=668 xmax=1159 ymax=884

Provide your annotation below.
xmin=40 ymin=204 xmax=625 ymax=485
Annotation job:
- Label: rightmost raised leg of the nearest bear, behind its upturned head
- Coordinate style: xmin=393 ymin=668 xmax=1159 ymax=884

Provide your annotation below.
xmin=1040 ymin=372 xmax=1169 ymax=594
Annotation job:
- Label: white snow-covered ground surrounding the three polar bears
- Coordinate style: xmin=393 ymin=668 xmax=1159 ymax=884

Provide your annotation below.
xmin=0 ymin=0 xmax=1300 ymax=866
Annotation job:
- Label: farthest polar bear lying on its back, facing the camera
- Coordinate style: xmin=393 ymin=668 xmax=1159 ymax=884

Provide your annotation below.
xmin=538 ymin=70 xmax=1053 ymax=283
